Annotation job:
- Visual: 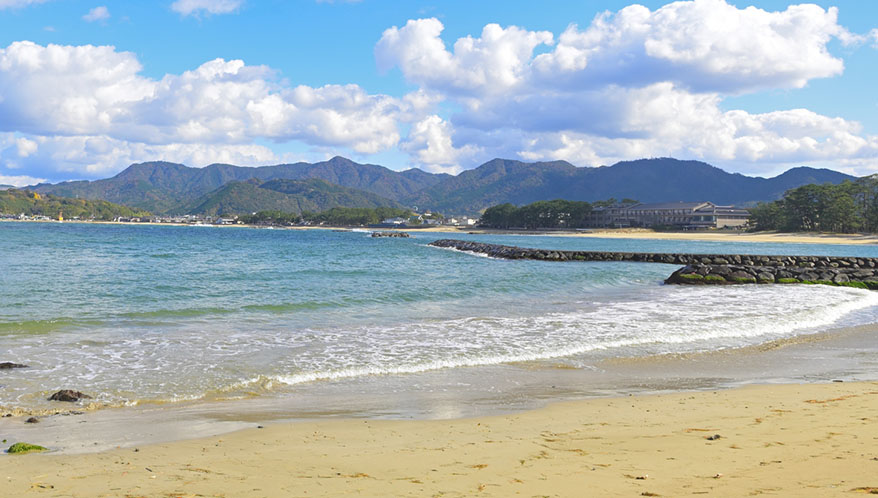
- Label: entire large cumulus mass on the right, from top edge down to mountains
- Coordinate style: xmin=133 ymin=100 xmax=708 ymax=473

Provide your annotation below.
xmin=375 ymin=0 xmax=878 ymax=172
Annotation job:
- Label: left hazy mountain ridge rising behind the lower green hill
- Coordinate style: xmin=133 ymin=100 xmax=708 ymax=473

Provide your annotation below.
xmin=34 ymin=157 xmax=449 ymax=213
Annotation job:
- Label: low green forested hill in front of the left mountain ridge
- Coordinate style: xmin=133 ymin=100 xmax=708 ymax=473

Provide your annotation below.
xmin=180 ymin=178 xmax=400 ymax=215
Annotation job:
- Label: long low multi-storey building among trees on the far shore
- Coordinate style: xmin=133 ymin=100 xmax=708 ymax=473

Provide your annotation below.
xmin=586 ymin=202 xmax=750 ymax=230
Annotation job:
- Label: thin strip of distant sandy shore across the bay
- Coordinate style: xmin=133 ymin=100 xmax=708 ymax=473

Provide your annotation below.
xmin=6 ymin=220 xmax=878 ymax=245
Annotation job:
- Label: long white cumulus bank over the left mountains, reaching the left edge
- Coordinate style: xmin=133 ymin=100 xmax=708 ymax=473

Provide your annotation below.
xmin=0 ymin=42 xmax=428 ymax=179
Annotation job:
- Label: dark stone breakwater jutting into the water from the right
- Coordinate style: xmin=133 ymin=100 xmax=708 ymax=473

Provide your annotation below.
xmin=430 ymin=239 xmax=878 ymax=289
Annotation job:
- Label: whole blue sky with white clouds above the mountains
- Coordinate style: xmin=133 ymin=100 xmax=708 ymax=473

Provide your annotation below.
xmin=0 ymin=0 xmax=878 ymax=186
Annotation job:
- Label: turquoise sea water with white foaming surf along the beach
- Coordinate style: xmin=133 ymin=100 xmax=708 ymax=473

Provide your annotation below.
xmin=0 ymin=223 xmax=878 ymax=412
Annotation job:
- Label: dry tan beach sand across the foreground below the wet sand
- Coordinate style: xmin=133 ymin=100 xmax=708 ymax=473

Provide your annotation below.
xmin=0 ymin=382 xmax=878 ymax=497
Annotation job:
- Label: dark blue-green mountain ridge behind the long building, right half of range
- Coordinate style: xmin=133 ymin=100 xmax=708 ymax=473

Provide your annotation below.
xmin=403 ymin=158 xmax=855 ymax=213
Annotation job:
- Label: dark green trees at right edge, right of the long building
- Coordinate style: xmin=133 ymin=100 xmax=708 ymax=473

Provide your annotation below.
xmin=750 ymin=179 xmax=878 ymax=233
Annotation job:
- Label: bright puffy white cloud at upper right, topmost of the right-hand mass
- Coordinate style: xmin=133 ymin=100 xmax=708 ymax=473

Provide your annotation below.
xmin=534 ymin=0 xmax=848 ymax=93
